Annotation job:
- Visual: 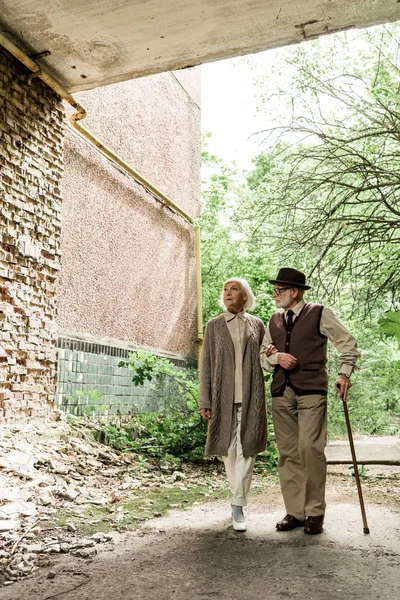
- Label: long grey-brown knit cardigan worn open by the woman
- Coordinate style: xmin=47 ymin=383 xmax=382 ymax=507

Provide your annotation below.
xmin=199 ymin=314 xmax=267 ymax=457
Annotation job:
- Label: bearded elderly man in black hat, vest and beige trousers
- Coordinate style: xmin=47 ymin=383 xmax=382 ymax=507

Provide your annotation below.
xmin=260 ymin=268 xmax=360 ymax=534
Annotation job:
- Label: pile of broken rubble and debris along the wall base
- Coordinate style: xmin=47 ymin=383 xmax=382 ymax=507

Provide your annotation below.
xmin=0 ymin=413 xmax=223 ymax=585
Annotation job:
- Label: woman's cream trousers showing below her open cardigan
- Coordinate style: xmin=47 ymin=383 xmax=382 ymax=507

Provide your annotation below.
xmin=222 ymin=404 xmax=256 ymax=506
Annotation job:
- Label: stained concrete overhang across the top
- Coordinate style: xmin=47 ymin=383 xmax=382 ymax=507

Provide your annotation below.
xmin=0 ymin=0 xmax=400 ymax=92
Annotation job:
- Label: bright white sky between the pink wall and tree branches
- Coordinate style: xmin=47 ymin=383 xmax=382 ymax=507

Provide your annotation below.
xmin=201 ymin=22 xmax=388 ymax=170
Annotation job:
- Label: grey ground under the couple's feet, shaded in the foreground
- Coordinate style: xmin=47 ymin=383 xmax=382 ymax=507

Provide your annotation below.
xmin=0 ymin=495 xmax=400 ymax=600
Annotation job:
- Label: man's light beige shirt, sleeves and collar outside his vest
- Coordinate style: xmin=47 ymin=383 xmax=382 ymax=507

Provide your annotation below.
xmin=260 ymin=300 xmax=360 ymax=377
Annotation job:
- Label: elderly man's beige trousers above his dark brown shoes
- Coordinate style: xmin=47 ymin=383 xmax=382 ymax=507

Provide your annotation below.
xmin=272 ymin=387 xmax=327 ymax=520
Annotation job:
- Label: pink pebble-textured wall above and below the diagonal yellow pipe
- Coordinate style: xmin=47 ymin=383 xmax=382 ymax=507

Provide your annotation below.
xmin=57 ymin=69 xmax=200 ymax=356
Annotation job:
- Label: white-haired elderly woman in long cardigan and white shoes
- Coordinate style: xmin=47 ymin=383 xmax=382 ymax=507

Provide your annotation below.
xmin=199 ymin=277 xmax=267 ymax=531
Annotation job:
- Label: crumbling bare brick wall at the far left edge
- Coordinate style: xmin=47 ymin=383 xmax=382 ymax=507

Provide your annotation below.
xmin=0 ymin=50 xmax=64 ymax=420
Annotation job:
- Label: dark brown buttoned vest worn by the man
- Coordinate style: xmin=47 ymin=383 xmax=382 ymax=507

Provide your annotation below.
xmin=269 ymin=303 xmax=328 ymax=397
